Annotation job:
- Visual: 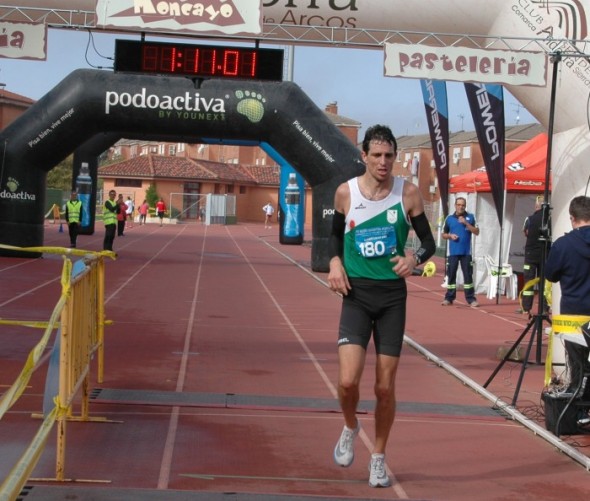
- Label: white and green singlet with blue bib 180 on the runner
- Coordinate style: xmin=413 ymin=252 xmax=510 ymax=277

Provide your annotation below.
xmin=344 ymin=177 xmax=410 ymax=280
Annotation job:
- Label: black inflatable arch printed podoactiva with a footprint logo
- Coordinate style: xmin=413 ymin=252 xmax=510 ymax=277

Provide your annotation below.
xmin=0 ymin=70 xmax=364 ymax=271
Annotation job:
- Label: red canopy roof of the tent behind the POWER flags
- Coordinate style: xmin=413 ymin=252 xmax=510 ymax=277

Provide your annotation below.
xmin=449 ymin=133 xmax=551 ymax=193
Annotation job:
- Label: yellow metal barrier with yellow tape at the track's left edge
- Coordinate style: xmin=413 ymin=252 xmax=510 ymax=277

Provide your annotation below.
xmin=0 ymin=245 xmax=115 ymax=501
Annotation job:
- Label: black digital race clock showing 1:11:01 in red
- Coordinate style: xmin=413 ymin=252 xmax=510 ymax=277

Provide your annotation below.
xmin=115 ymin=40 xmax=284 ymax=81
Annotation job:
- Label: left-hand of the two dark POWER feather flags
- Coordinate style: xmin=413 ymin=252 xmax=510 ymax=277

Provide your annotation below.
xmin=420 ymin=80 xmax=449 ymax=217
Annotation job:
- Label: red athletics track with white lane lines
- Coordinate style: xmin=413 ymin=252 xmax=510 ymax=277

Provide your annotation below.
xmin=0 ymin=223 xmax=590 ymax=501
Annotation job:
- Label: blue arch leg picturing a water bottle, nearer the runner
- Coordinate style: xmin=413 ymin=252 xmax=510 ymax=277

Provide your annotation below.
xmin=279 ymin=165 xmax=305 ymax=245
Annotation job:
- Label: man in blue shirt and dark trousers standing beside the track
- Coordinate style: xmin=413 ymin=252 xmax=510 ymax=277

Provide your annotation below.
xmin=441 ymin=197 xmax=479 ymax=308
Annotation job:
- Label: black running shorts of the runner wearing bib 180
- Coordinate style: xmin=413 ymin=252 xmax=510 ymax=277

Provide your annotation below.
xmin=338 ymin=278 xmax=408 ymax=357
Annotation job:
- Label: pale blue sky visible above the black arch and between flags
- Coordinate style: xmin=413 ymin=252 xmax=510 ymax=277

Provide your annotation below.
xmin=0 ymin=28 xmax=537 ymax=137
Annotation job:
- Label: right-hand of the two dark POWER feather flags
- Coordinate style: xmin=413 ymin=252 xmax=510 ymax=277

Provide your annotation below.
xmin=465 ymin=83 xmax=504 ymax=226
